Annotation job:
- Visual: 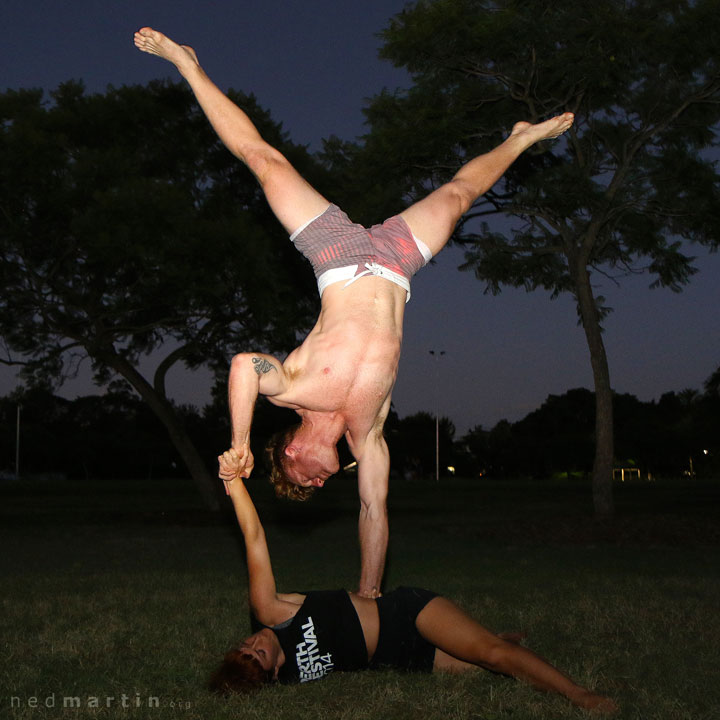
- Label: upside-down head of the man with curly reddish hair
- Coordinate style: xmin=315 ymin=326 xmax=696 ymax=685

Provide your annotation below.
xmin=268 ymin=424 xmax=340 ymax=501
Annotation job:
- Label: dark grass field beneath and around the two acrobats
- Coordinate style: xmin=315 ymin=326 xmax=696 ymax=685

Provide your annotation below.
xmin=0 ymin=478 xmax=720 ymax=720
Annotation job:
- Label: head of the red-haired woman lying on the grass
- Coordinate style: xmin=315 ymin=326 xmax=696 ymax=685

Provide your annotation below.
xmin=208 ymin=629 xmax=285 ymax=695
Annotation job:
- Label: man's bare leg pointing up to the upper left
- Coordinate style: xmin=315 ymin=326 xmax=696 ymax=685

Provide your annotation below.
xmin=135 ymin=28 xmax=330 ymax=234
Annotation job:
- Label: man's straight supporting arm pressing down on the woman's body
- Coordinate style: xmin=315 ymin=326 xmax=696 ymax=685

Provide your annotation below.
xmin=355 ymin=431 xmax=390 ymax=598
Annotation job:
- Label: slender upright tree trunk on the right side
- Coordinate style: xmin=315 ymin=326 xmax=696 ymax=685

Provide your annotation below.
xmin=575 ymin=263 xmax=615 ymax=520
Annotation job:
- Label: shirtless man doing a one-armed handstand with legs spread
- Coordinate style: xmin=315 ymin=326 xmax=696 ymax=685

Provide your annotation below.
xmin=135 ymin=28 xmax=573 ymax=597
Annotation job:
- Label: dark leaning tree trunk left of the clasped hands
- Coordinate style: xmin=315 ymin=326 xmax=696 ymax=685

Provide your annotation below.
xmin=103 ymin=350 xmax=220 ymax=512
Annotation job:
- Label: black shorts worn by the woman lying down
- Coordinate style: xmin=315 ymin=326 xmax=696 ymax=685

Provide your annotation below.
xmin=370 ymin=587 xmax=437 ymax=672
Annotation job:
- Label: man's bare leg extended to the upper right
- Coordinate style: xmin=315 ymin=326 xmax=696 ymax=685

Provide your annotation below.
xmin=400 ymin=113 xmax=573 ymax=255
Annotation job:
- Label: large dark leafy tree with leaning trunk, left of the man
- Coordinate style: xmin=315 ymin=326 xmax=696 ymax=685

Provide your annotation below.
xmin=0 ymin=82 xmax=317 ymax=507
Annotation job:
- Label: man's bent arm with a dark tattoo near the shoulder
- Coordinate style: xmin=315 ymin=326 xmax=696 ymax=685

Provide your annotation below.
xmin=223 ymin=353 xmax=289 ymax=479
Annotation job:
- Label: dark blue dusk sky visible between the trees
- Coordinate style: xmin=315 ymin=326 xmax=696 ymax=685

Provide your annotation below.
xmin=0 ymin=0 xmax=720 ymax=433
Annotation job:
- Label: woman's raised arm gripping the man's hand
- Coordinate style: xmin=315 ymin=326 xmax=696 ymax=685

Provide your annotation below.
xmin=219 ymin=449 xmax=298 ymax=625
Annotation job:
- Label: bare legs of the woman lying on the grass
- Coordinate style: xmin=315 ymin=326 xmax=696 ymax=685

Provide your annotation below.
xmin=415 ymin=597 xmax=617 ymax=713
